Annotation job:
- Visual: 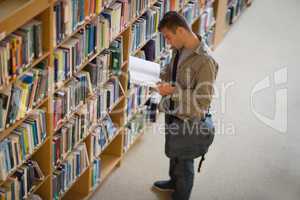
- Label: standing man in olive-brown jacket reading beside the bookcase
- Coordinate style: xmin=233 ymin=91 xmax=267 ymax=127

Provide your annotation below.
xmin=154 ymin=11 xmax=218 ymax=200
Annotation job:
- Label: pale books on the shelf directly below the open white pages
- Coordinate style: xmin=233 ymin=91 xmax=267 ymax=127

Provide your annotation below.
xmin=125 ymin=85 xmax=149 ymax=121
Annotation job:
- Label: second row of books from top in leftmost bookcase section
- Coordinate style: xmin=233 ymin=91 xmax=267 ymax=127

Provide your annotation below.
xmin=0 ymin=63 xmax=48 ymax=131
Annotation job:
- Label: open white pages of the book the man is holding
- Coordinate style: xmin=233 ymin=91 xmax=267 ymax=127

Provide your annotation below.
xmin=129 ymin=56 xmax=160 ymax=87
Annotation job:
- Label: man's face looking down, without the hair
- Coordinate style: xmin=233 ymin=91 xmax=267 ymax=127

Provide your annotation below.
xmin=161 ymin=27 xmax=183 ymax=49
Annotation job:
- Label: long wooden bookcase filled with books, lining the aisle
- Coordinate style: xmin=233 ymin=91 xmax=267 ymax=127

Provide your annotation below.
xmin=0 ymin=0 xmax=248 ymax=200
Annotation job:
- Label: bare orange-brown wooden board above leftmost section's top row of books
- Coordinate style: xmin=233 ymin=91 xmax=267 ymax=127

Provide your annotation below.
xmin=0 ymin=0 xmax=49 ymax=40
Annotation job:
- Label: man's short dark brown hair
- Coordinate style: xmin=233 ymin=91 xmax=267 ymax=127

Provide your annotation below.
xmin=158 ymin=11 xmax=190 ymax=32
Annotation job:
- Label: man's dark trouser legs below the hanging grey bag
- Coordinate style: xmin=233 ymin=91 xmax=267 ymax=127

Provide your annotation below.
xmin=169 ymin=158 xmax=194 ymax=200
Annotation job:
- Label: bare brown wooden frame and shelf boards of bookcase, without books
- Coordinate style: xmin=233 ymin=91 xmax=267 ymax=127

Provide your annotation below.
xmin=0 ymin=0 xmax=244 ymax=200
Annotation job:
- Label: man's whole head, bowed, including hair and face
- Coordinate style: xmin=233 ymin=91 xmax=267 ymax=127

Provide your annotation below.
xmin=158 ymin=11 xmax=191 ymax=49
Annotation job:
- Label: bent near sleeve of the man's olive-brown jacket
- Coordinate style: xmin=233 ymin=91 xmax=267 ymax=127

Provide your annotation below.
xmin=172 ymin=57 xmax=218 ymax=119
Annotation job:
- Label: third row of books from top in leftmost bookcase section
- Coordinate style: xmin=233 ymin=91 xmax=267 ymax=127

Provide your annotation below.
xmin=0 ymin=109 xmax=47 ymax=181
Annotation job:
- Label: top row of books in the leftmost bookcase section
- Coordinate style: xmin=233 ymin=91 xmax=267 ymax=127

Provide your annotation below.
xmin=0 ymin=20 xmax=43 ymax=86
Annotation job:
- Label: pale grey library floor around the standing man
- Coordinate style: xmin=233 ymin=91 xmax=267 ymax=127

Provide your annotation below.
xmin=91 ymin=0 xmax=300 ymax=200
